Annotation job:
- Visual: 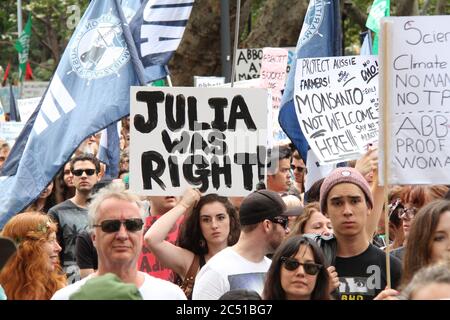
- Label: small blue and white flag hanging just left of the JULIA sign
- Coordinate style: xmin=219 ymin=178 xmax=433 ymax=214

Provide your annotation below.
xmin=97 ymin=122 xmax=120 ymax=178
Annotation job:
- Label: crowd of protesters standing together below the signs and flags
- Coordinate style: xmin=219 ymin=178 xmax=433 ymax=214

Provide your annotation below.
xmin=0 ymin=118 xmax=450 ymax=300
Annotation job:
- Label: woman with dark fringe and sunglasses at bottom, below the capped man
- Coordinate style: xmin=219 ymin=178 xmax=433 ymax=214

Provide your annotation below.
xmin=263 ymin=235 xmax=331 ymax=300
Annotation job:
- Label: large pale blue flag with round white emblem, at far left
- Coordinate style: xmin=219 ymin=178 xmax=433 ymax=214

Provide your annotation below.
xmin=0 ymin=0 xmax=192 ymax=229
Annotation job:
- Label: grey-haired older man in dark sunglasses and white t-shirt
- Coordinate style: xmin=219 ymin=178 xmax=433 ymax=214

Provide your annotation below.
xmin=52 ymin=182 xmax=186 ymax=300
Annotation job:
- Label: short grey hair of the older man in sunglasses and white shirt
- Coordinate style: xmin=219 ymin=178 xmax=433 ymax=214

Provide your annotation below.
xmin=88 ymin=182 xmax=145 ymax=232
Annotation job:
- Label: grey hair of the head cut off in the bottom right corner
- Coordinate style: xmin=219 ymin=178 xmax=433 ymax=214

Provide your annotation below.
xmin=401 ymin=257 xmax=450 ymax=300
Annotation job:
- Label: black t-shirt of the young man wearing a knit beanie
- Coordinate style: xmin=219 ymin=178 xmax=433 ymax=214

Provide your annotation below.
xmin=335 ymin=244 xmax=402 ymax=300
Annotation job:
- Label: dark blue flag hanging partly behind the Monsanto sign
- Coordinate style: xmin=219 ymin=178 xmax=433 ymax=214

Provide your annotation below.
xmin=278 ymin=0 xmax=342 ymax=189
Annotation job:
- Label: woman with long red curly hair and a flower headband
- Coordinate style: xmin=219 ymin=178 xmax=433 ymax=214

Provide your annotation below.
xmin=0 ymin=212 xmax=66 ymax=300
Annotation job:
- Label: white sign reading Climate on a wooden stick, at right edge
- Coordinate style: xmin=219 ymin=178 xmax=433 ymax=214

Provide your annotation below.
xmin=379 ymin=16 xmax=450 ymax=184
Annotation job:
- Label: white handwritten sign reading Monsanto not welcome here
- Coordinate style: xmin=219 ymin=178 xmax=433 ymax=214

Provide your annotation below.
xmin=294 ymin=56 xmax=378 ymax=164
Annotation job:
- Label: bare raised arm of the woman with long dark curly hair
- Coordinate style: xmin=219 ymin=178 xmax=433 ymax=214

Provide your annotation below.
xmin=144 ymin=188 xmax=200 ymax=278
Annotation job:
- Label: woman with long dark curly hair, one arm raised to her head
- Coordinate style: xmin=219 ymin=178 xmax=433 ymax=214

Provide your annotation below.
xmin=144 ymin=188 xmax=240 ymax=299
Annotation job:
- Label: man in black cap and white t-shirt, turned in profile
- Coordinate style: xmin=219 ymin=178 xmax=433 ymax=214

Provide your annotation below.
xmin=192 ymin=190 xmax=289 ymax=300
